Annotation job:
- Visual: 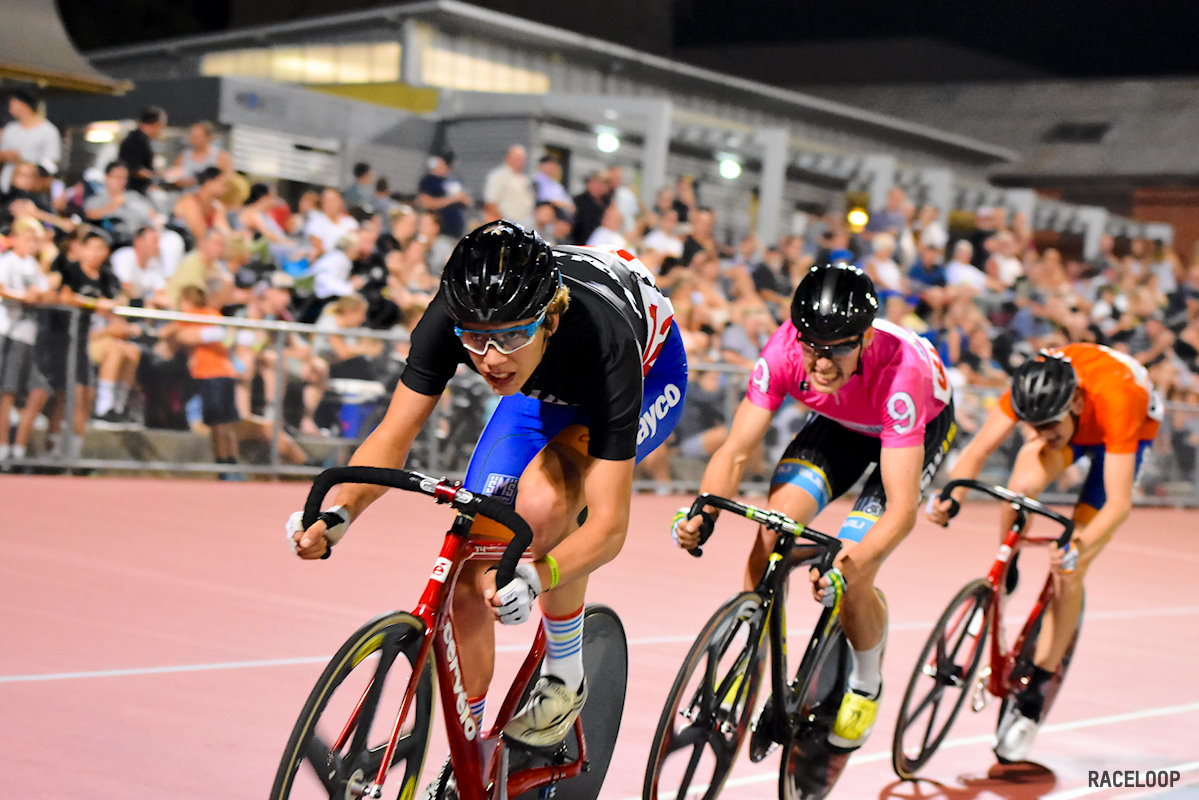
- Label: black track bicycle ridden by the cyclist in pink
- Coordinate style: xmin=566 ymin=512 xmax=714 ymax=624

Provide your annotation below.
xmin=641 ymin=494 xmax=850 ymax=800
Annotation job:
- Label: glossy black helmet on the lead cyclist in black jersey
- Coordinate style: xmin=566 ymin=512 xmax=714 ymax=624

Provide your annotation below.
xmin=441 ymin=219 xmax=560 ymax=324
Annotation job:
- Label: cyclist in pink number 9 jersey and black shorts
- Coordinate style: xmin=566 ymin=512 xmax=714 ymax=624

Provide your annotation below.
xmin=673 ymin=264 xmax=957 ymax=748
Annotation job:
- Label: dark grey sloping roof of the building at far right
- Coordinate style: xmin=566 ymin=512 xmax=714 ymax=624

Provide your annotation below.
xmin=807 ymin=78 xmax=1199 ymax=185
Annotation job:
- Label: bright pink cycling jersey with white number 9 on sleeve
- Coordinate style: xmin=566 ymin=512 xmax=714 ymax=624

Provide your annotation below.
xmin=746 ymin=320 xmax=953 ymax=447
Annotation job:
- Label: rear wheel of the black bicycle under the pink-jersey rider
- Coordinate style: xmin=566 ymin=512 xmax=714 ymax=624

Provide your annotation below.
xmin=778 ymin=612 xmax=850 ymax=800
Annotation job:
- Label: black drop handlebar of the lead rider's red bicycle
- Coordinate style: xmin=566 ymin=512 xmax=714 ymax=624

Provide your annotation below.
xmin=303 ymin=467 xmax=532 ymax=587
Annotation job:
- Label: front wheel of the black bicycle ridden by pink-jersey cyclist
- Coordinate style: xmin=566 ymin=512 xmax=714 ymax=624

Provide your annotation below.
xmin=641 ymin=591 xmax=766 ymax=800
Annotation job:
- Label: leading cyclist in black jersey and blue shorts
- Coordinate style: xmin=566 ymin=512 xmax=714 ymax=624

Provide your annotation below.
xmin=288 ymin=219 xmax=687 ymax=747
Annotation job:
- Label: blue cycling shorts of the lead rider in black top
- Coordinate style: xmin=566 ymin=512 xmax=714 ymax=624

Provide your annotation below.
xmin=463 ymin=325 xmax=687 ymax=504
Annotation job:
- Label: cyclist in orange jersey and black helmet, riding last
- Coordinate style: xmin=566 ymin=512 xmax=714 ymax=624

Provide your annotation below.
xmin=927 ymin=344 xmax=1162 ymax=762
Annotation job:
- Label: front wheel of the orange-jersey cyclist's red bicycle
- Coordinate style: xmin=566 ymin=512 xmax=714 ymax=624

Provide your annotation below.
xmin=891 ymin=578 xmax=993 ymax=781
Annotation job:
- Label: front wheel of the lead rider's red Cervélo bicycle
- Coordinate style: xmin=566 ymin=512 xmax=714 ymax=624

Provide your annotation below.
xmin=271 ymin=612 xmax=433 ymax=800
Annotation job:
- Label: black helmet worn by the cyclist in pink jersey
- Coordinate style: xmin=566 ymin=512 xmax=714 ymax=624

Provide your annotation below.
xmin=791 ymin=264 xmax=879 ymax=342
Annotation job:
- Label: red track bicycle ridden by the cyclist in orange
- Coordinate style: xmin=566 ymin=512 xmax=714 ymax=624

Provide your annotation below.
xmin=891 ymin=480 xmax=1083 ymax=780
